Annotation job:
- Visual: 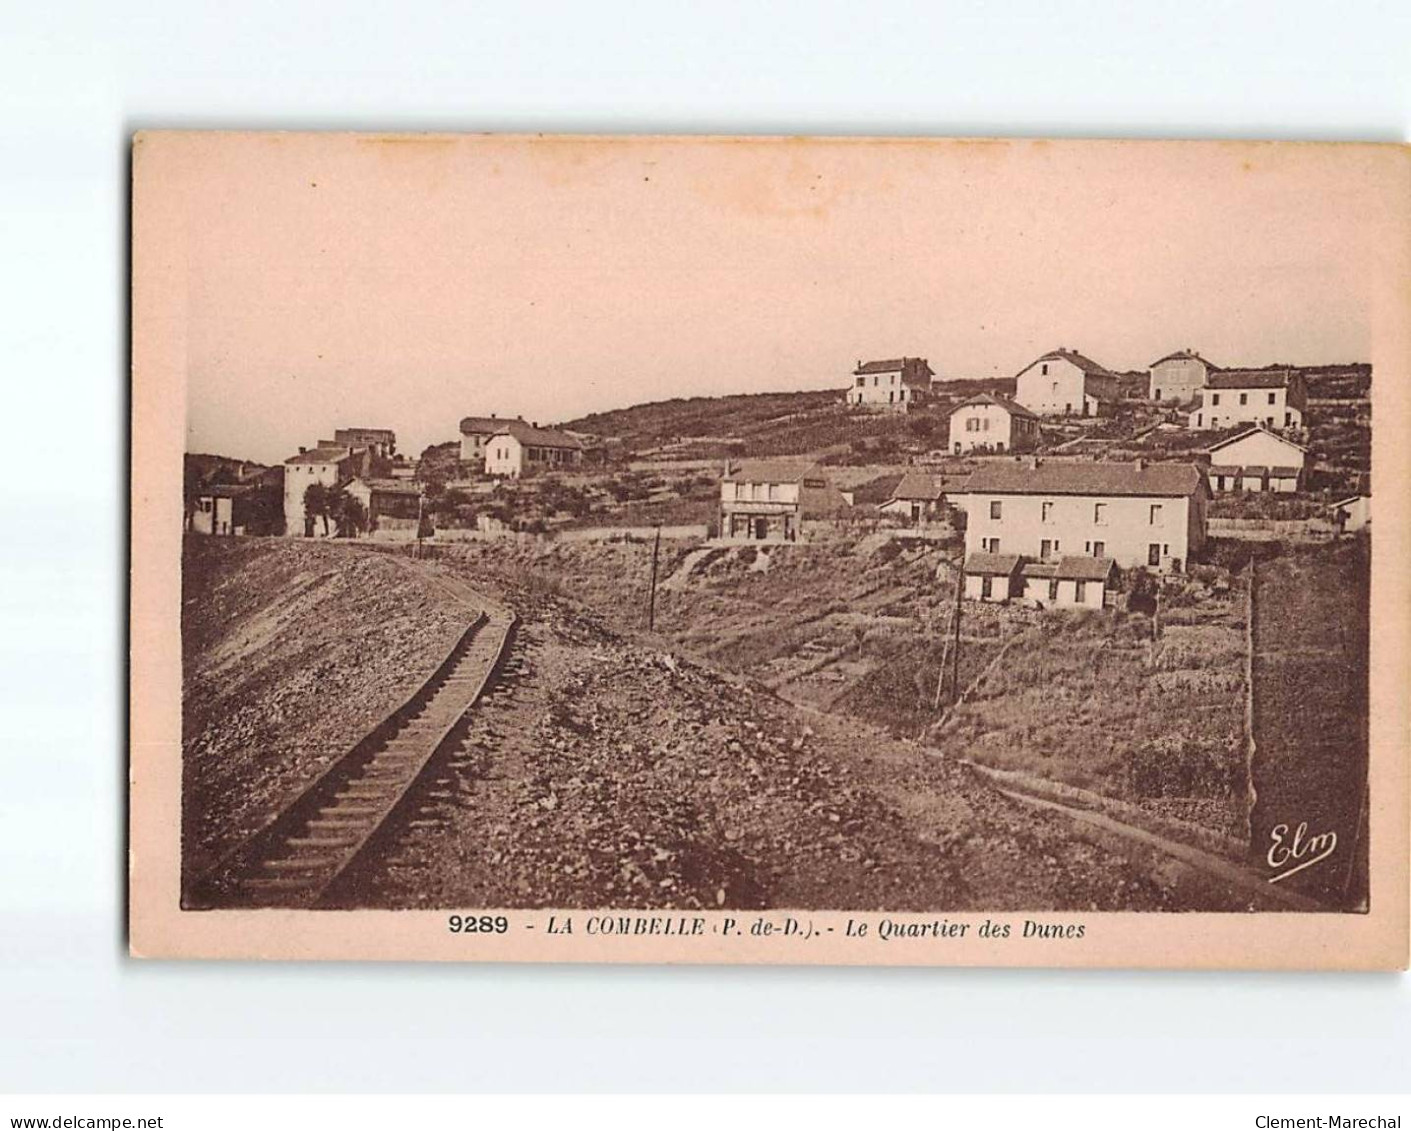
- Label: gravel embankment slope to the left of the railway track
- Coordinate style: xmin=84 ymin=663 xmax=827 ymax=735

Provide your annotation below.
xmin=182 ymin=537 xmax=474 ymax=879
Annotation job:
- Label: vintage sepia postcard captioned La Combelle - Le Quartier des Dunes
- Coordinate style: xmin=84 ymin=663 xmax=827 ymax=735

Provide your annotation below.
xmin=130 ymin=131 xmax=1411 ymax=969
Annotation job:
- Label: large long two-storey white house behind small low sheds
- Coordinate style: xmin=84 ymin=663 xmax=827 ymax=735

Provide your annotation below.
xmin=951 ymin=457 xmax=1209 ymax=570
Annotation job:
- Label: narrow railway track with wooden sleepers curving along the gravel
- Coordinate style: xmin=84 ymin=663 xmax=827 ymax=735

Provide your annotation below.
xmin=188 ymin=577 xmax=516 ymax=908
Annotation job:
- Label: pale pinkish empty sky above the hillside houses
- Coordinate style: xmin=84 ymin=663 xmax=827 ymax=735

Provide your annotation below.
xmin=167 ymin=134 xmax=1388 ymax=463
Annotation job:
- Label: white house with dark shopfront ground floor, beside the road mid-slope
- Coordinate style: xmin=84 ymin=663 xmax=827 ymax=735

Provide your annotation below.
xmin=720 ymin=460 xmax=849 ymax=542
